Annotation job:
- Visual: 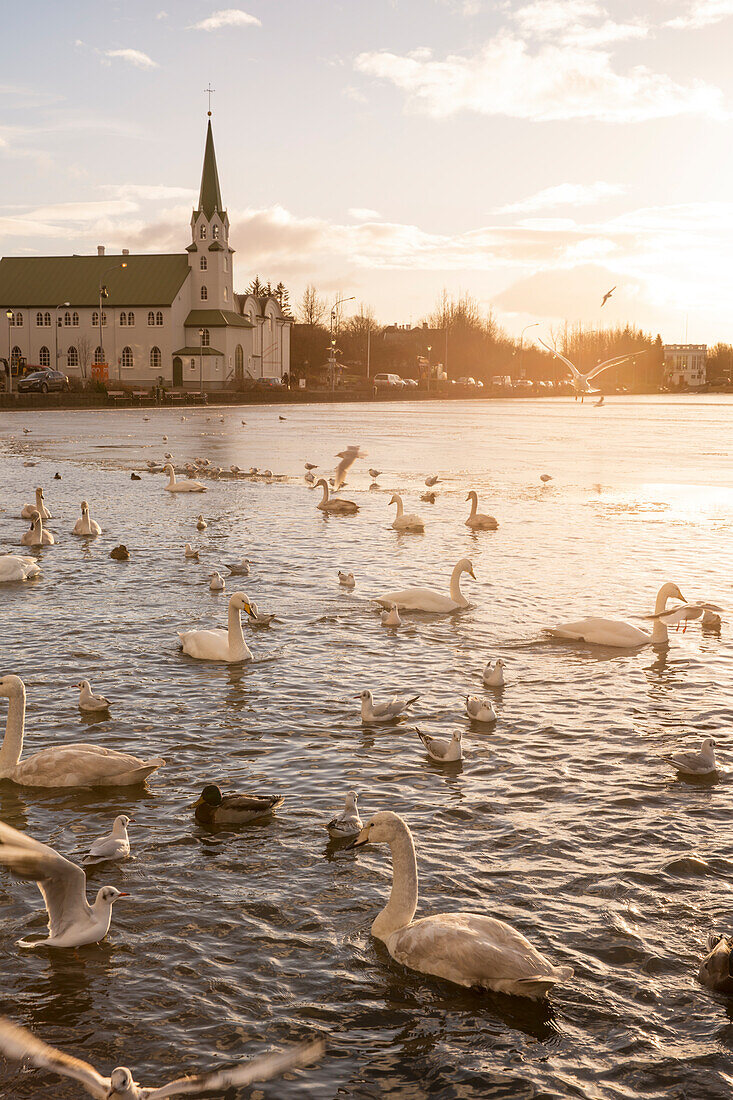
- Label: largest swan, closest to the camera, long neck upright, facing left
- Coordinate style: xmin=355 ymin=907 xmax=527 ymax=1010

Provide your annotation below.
xmin=349 ymin=810 xmax=572 ymax=1000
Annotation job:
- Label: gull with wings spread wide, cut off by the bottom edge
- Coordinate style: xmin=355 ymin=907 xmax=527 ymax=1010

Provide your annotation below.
xmin=0 ymin=1016 xmax=325 ymax=1100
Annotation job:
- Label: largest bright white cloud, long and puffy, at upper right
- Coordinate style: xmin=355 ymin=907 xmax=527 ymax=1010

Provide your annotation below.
xmin=354 ymin=32 xmax=725 ymax=123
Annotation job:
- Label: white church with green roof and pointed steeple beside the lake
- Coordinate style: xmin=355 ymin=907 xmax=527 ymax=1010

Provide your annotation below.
xmin=0 ymin=112 xmax=293 ymax=391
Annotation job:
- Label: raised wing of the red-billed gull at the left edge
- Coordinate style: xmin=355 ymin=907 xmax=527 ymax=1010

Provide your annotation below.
xmin=0 ymin=822 xmax=91 ymax=936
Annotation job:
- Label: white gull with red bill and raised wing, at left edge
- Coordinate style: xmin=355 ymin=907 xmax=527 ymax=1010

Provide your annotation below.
xmin=0 ymin=822 xmax=129 ymax=950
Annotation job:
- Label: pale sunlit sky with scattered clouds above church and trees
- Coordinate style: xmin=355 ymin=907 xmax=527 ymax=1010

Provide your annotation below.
xmin=0 ymin=0 xmax=733 ymax=344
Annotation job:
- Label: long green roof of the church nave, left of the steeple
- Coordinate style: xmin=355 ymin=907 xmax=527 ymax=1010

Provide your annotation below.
xmin=0 ymin=252 xmax=189 ymax=309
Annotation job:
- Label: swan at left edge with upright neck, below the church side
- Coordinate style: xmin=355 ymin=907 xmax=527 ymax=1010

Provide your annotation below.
xmin=0 ymin=675 xmax=165 ymax=787
